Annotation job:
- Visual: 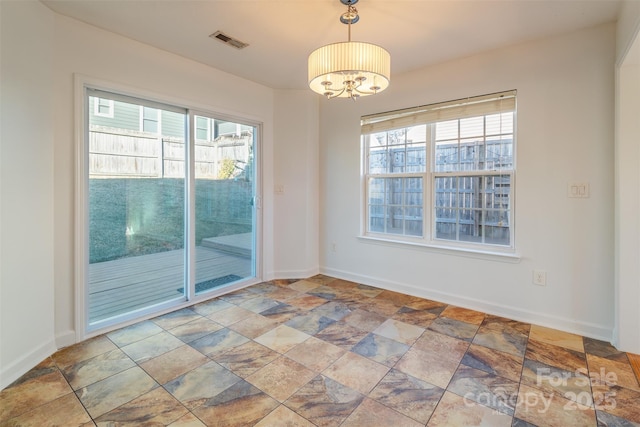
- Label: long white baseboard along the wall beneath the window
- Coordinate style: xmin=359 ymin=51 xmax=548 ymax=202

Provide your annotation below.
xmin=320 ymin=267 xmax=613 ymax=342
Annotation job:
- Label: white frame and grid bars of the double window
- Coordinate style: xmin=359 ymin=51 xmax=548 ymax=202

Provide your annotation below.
xmin=359 ymin=90 xmax=517 ymax=257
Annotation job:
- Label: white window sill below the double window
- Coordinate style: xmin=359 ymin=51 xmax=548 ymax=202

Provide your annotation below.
xmin=358 ymin=235 xmax=521 ymax=264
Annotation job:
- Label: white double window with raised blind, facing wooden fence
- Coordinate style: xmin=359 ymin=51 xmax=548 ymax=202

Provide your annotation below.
xmin=362 ymin=91 xmax=516 ymax=250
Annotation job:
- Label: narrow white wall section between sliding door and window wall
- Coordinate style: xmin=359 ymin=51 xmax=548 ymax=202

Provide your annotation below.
xmin=272 ymin=90 xmax=320 ymax=278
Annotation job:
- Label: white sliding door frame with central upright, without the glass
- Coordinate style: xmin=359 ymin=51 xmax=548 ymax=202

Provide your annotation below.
xmin=74 ymin=74 xmax=263 ymax=342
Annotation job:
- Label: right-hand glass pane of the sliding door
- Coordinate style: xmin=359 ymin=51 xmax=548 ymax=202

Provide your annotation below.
xmin=194 ymin=115 xmax=258 ymax=295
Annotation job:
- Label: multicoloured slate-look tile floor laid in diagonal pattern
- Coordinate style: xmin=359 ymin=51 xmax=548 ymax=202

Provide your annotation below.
xmin=0 ymin=275 xmax=640 ymax=427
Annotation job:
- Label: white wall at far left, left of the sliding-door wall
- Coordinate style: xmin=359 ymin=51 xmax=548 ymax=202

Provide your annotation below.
xmin=0 ymin=2 xmax=55 ymax=388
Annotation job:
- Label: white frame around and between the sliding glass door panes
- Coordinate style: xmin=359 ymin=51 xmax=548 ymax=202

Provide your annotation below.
xmin=74 ymin=74 xmax=264 ymax=341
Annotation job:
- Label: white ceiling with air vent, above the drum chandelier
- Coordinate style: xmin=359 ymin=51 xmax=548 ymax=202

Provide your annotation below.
xmin=42 ymin=0 xmax=621 ymax=89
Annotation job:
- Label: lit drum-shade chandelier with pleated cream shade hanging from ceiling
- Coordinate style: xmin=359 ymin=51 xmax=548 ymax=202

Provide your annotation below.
xmin=309 ymin=0 xmax=391 ymax=100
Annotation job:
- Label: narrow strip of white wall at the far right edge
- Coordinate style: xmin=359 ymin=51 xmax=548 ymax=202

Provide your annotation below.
xmin=614 ymin=1 xmax=640 ymax=353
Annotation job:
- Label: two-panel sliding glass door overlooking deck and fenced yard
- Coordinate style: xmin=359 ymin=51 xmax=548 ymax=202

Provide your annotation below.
xmin=85 ymin=88 xmax=259 ymax=330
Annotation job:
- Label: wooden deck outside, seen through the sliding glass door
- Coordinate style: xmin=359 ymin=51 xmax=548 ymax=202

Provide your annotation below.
xmin=89 ymin=246 xmax=251 ymax=323
